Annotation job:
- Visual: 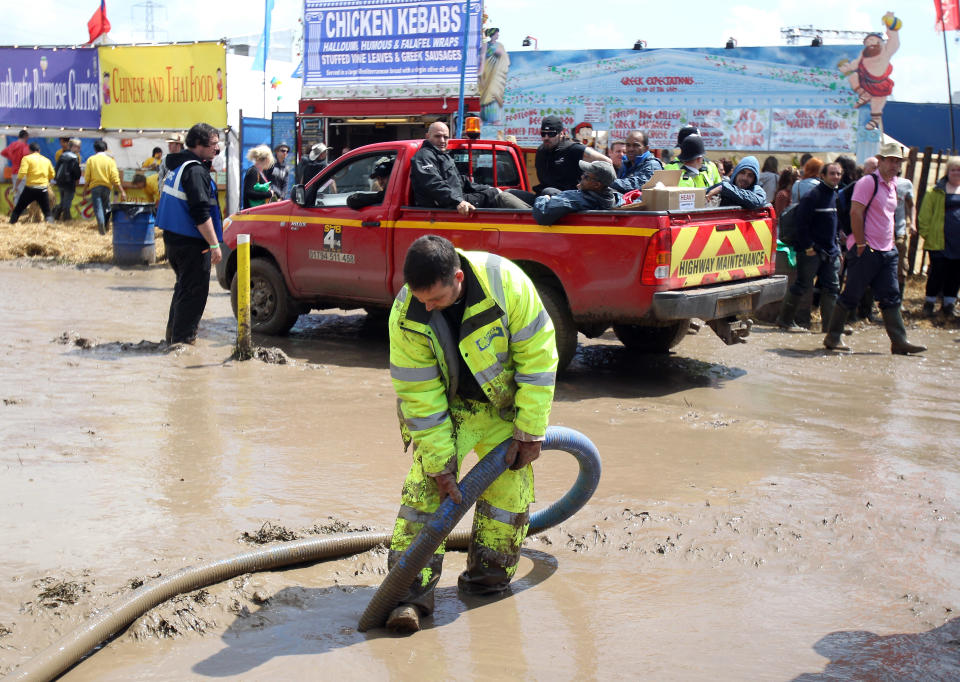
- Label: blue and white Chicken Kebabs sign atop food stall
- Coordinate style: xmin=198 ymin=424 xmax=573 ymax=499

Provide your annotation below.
xmin=303 ymin=0 xmax=482 ymax=97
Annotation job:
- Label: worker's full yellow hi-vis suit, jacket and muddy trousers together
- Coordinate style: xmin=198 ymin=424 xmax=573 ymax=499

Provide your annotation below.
xmin=388 ymin=251 xmax=557 ymax=615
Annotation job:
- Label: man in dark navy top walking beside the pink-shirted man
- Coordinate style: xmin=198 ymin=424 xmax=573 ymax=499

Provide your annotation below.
xmin=776 ymin=162 xmax=843 ymax=332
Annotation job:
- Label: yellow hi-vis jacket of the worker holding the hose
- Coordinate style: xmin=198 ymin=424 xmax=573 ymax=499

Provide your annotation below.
xmin=389 ymin=249 xmax=557 ymax=473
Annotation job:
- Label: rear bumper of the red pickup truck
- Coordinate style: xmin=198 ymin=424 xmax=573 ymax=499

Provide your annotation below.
xmin=652 ymin=275 xmax=787 ymax=320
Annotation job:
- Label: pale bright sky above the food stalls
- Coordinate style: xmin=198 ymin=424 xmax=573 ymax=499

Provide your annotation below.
xmin=0 ymin=0 xmax=960 ymax=102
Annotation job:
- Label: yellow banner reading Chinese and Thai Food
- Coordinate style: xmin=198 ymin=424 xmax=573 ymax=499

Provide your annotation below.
xmin=99 ymin=43 xmax=227 ymax=130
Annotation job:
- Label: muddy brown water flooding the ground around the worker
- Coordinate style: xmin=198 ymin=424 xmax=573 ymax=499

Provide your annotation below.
xmin=0 ymin=262 xmax=960 ymax=681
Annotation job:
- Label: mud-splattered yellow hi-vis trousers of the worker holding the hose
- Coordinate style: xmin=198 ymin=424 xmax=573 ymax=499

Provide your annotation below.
xmin=387 ymin=397 xmax=534 ymax=615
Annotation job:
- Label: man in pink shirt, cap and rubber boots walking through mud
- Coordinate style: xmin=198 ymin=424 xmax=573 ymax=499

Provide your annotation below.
xmin=823 ymin=142 xmax=926 ymax=355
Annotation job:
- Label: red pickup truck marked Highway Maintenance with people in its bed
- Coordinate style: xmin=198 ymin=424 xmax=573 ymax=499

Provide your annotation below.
xmin=217 ymin=140 xmax=786 ymax=367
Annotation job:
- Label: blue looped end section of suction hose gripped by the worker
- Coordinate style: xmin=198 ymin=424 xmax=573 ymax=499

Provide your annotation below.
xmin=357 ymin=426 xmax=600 ymax=632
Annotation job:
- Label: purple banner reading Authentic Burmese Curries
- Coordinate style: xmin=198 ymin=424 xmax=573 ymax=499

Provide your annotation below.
xmin=0 ymin=47 xmax=100 ymax=128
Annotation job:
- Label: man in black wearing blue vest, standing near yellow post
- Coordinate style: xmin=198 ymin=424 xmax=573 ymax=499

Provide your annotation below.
xmin=157 ymin=123 xmax=223 ymax=344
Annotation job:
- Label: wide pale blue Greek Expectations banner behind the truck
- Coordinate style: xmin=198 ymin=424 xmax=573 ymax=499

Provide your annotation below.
xmin=482 ymin=45 xmax=872 ymax=152
